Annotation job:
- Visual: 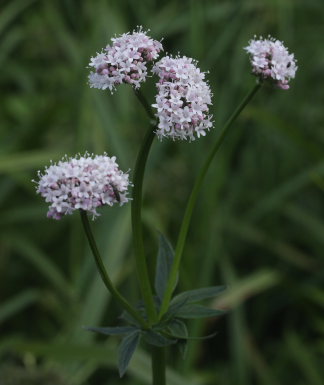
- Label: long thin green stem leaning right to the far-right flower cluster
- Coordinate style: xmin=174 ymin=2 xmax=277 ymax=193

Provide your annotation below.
xmin=159 ymin=83 xmax=261 ymax=318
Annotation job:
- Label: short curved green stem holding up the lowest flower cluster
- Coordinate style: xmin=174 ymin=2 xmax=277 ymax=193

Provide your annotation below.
xmin=80 ymin=210 xmax=148 ymax=329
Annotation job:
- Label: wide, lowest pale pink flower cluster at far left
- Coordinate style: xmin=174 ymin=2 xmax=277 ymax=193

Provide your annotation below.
xmin=34 ymin=153 xmax=129 ymax=219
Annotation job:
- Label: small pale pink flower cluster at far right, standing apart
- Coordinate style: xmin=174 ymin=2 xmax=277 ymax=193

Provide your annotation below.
xmin=244 ymin=36 xmax=298 ymax=90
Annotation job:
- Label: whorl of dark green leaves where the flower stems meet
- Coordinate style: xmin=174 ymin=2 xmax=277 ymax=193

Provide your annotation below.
xmin=86 ymin=234 xmax=226 ymax=376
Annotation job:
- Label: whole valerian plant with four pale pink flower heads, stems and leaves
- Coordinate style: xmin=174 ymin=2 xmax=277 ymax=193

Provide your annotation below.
xmin=36 ymin=28 xmax=297 ymax=385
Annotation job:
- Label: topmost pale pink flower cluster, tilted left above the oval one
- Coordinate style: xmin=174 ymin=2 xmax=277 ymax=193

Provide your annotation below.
xmin=89 ymin=27 xmax=163 ymax=92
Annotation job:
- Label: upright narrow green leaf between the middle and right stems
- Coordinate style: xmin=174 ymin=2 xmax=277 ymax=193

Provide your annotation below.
xmin=154 ymin=234 xmax=174 ymax=301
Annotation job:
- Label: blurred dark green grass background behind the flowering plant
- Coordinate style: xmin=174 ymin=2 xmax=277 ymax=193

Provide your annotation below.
xmin=0 ymin=0 xmax=324 ymax=385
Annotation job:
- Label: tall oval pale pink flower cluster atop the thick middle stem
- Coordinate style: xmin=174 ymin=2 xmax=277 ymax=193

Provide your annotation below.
xmin=152 ymin=56 xmax=212 ymax=141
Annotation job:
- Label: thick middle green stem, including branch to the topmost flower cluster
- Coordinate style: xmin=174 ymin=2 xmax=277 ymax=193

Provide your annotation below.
xmin=132 ymin=91 xmax=157 ymax=324
